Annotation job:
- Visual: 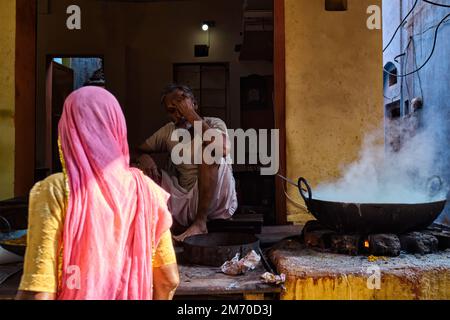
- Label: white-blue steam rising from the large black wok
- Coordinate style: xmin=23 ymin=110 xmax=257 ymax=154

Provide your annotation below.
xmin=313 ymin=107 xmax=448 ymax=204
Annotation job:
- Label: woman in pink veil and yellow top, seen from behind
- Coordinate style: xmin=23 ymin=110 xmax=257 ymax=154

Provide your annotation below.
xmin=18 ymin=87 xmax=179 ymax=300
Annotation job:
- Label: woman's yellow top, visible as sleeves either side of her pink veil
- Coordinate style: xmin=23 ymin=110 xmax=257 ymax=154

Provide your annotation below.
xmin=19 ymin=173 xmax=176 ymax=293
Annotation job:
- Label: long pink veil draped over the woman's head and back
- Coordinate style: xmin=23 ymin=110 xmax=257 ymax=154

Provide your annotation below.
xmin=58 ymin=87 xmax=172 ymax=300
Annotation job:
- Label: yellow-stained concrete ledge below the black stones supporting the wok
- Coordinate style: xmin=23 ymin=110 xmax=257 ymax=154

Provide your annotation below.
xmin=270 ymin=240 xmax=450 ymax=300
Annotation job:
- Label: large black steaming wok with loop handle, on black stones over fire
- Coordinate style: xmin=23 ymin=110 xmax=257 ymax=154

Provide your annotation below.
xmin=298 ymin=178 xmax=447 ymax=234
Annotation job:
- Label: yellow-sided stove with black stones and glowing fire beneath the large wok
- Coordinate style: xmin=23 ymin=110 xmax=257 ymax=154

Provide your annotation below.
xmin=269 ymin=221 xmax=450 ymax=300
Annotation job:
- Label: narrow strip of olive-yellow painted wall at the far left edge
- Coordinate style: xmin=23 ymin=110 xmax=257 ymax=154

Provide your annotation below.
xmin=0 ymin=0 xmax=16 ymax=199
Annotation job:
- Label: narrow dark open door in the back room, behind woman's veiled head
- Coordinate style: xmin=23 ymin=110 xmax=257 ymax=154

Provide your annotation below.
xmin=45 ymin=61 xmax=74 ymax=175
